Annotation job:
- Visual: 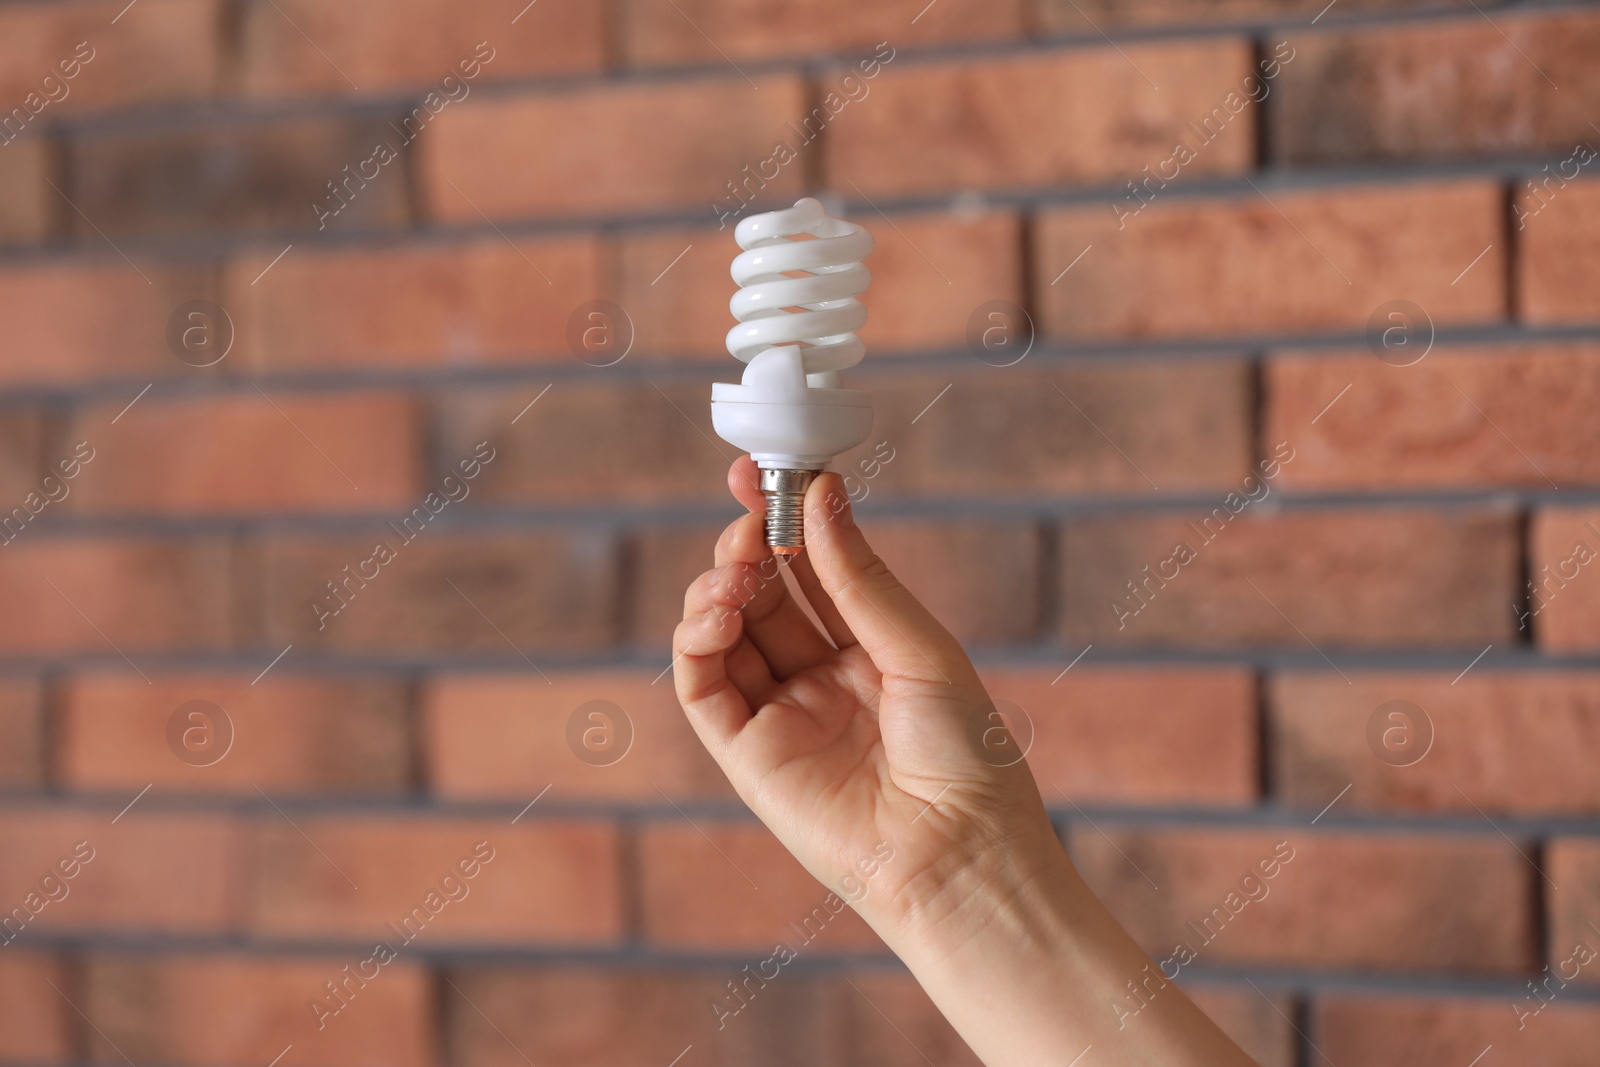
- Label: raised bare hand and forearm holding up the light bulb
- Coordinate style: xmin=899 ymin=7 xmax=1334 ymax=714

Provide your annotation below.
xmin=674 ymin=459 xmax=1251 ymax=1067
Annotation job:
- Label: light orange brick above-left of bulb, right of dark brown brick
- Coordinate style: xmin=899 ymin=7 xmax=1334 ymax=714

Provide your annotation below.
xmin=419 ymin=77 xmax=803 ymax=224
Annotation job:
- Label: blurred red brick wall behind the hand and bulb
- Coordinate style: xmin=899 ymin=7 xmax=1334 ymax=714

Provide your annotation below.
xmin=0 ymin=0 xmax=1600 ymax=1067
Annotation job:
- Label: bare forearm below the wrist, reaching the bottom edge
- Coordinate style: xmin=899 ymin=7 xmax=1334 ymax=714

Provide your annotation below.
xmin=869 ymin=840 xmax=1251 ymax=1067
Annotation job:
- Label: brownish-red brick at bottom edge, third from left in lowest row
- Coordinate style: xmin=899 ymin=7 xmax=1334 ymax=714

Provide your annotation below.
xmin=443 ymin=966 xmax=845 ymax=1067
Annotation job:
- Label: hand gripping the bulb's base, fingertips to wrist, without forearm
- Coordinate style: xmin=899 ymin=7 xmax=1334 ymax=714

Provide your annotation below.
xmin=674 ymin=458 xmax=1064 ymax=936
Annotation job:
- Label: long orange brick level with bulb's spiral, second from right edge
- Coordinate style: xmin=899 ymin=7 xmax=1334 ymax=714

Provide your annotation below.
xmin=1034 ymin=182 xmax=1506 ymax=341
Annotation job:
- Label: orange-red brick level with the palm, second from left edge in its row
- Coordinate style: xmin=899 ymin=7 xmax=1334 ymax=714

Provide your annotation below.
xmin=58 ymin=669 xmax=411 ymax=798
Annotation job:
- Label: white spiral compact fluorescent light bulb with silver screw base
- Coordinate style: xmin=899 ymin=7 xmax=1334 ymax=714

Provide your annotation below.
xmin=710 ymin=197 xmax=872 ymax=555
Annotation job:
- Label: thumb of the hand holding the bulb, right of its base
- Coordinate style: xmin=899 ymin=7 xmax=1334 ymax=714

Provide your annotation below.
xmin=805 ymin=474 xmax=978 ymax=686
